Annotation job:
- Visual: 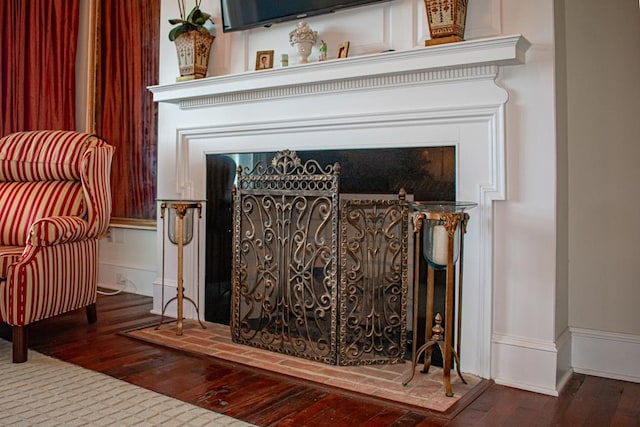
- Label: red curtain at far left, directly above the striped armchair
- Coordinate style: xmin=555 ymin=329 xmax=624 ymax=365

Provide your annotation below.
xmin=0 ymin=0 xmax=79 ymax=135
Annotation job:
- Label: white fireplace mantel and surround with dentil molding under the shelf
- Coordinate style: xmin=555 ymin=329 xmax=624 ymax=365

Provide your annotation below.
xmin=151 ymin=36 xmax=528 ymax=377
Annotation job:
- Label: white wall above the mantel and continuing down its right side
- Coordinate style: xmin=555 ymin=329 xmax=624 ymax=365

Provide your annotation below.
xmin=159 ymin=0 xmax=570 ymax=394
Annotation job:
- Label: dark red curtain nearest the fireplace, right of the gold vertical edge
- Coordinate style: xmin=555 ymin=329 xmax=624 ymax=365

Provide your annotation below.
xmin=95 ymin=0 xmax=160 ymax=219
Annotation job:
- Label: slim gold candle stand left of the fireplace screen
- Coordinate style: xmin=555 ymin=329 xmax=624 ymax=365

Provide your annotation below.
xmin=157 ymin=200 xmax=206 ymax=335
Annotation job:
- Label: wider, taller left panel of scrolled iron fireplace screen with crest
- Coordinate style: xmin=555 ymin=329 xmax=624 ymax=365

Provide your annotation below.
xmin=231 ymin=151 xmax=339 ymax=364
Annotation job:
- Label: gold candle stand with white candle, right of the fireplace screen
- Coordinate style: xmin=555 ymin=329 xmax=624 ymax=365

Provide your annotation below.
xmin=402 ymin=202 xmax=476 ymax=397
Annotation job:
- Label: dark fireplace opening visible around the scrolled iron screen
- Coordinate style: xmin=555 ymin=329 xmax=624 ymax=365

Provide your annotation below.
xmin=204 ymin=146 xmax=455 ymax=366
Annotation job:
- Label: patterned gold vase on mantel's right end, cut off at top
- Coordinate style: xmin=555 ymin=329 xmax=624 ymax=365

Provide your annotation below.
xmin=424 ymin=0 xmax=468 ymax=46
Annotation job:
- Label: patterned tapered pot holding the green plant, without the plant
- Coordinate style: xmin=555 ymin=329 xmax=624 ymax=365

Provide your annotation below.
xmin=175 ymin=31 xmax=215 ymax=81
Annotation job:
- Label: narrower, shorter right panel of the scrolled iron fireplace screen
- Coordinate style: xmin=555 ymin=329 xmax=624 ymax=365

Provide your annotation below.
xmin=339 ymin=196 xmax=408 ymax=365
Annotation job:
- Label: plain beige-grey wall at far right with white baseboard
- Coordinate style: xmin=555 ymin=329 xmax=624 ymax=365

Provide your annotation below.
xmin=565 ymin=0 xmax=640 ymax=381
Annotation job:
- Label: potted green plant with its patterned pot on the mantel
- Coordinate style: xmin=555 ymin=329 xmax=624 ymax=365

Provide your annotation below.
xmin=169 ymin=0 xmax=215 ymax=81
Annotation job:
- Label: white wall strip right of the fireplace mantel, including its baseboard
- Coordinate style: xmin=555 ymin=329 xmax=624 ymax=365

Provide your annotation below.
xmin=484 ymin=0 xmax=566 ymax=394
